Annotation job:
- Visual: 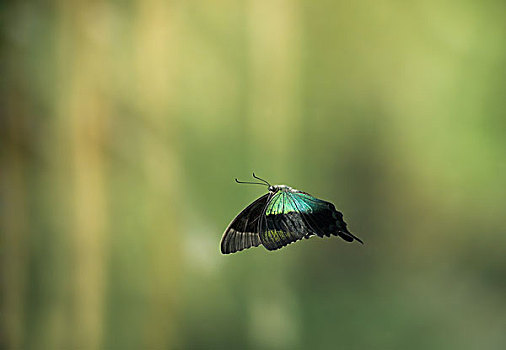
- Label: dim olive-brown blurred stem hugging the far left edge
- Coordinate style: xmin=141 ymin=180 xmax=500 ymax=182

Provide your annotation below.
xmin=0 ymin=96 xmax=28 ymax=349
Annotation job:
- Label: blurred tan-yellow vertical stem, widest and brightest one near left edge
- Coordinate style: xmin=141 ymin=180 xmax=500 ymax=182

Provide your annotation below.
xmin=57 ymin=2 xmax=110 ymax=349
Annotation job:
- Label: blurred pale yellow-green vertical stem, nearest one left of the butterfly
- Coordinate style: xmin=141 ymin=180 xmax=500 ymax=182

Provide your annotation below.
xmin=134 ymin=0 xmax=180 ymax=349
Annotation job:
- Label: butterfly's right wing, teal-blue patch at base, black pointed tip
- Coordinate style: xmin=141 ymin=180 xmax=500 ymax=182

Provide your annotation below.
xmin=288 ymin=191 xmax=363 ymax=243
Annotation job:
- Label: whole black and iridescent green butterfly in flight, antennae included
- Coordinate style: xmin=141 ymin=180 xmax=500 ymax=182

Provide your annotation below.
xmin=221 ymin=173 xmax=363 ymax=254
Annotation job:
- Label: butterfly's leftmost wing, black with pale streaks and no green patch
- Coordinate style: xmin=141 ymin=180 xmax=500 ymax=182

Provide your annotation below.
xmin=220 ymin=193 xmax=272 ymax=254
